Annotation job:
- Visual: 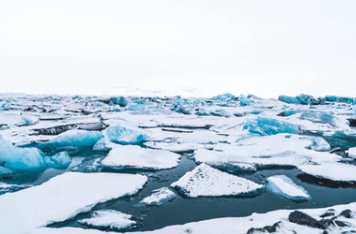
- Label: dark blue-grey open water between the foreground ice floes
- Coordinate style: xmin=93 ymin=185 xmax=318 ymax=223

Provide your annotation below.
xmin=49 ymin=152 xmax=356 ymax=231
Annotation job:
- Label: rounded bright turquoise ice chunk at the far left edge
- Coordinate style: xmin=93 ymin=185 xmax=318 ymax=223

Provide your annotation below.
xmin=0 ymin=136 xmax=45 ymax=170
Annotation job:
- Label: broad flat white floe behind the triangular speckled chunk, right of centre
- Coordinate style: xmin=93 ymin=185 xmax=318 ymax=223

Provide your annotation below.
xmin=194 ymin=134 xmax=341 ymax=169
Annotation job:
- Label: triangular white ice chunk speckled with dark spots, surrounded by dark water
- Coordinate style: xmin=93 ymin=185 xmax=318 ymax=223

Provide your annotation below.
xmin=171 ymin=163 xmax=263 ymax=197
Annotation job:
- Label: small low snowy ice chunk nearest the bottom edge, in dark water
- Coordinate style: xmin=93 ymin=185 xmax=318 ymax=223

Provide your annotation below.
xmin=78 ymin=210 xmax=137 ymax=231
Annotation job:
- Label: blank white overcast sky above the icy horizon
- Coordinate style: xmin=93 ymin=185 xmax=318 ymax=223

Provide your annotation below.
xmin=0 ymin=0 xmax=356 ymax=97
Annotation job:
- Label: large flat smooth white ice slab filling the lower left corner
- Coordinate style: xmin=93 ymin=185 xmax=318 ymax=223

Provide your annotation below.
xmin=0 ymin=172 xmax=147 ymax=234
